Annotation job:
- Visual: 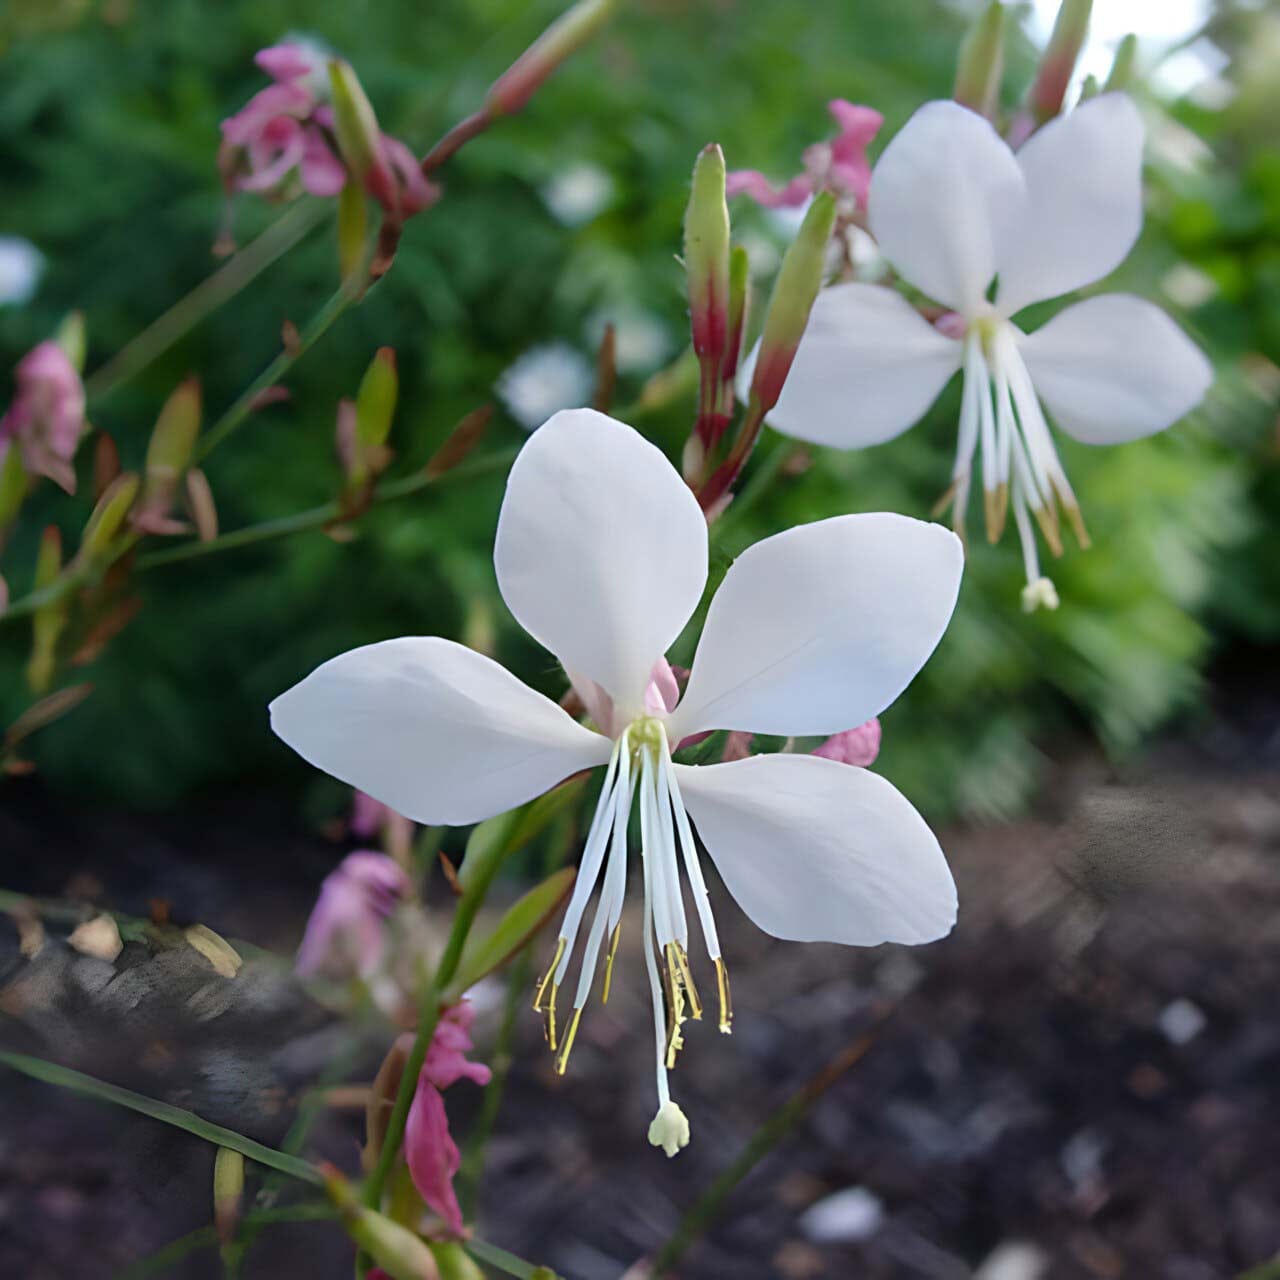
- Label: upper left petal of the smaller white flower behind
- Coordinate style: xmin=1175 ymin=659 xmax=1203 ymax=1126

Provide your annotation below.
xmin=867 ymin=102 xmax=1024 ymax=315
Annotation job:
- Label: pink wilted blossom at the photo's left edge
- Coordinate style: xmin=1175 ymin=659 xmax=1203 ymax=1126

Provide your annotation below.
xmin=0 ymin=342 xmax=86 ymax=493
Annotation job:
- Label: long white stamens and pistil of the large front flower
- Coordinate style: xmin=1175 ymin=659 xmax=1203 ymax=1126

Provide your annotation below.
xmin=534 ymin=716 xmax=733 ymax=1153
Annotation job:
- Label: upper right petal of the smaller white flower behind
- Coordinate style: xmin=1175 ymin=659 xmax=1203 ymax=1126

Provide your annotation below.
xmin=996 ymin=93 xmax=1143 ymax=315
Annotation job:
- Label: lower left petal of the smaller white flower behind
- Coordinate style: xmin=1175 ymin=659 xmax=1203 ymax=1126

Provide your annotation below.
xmin=748 ymin=284 xmax=963 ymax=449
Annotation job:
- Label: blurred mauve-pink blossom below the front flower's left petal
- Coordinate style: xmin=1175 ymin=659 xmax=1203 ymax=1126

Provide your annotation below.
xmin=297 ymin=850 xmax=410 ymax=978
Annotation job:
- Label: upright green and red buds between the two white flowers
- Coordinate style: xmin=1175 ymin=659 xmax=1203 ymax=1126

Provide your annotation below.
xmin=682 ymin=143 xmax=836 ymax=520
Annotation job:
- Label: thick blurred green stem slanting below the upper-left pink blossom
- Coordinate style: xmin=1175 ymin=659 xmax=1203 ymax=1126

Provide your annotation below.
xmin=84 ymin=200 xmax=330 ymax=402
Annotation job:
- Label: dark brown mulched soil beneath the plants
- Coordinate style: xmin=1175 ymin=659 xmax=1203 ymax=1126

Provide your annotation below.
xmin=0 ymin=717 xmax=1280 ymax=1280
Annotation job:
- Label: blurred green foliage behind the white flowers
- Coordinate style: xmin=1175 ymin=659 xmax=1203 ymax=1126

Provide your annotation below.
xmin=0 ymin=0 xmax=1280 ymax=815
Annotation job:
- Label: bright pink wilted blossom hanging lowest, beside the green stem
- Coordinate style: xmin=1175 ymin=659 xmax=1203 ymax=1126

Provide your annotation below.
xmin=404 ymin=1004 xmax=492 ymax=1235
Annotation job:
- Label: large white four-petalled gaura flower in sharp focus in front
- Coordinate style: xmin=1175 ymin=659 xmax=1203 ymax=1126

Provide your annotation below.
xmin=271 ymin=410 xmax=963 ymax=1155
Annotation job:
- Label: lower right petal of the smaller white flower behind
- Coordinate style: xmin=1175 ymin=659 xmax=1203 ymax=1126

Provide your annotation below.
xmin=1019 ymin=293 xmax=1213 ymax=444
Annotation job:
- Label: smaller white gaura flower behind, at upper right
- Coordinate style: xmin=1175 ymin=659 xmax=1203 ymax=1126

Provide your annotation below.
xmin=769 ymin=93 xmax=1212 ymax=608
